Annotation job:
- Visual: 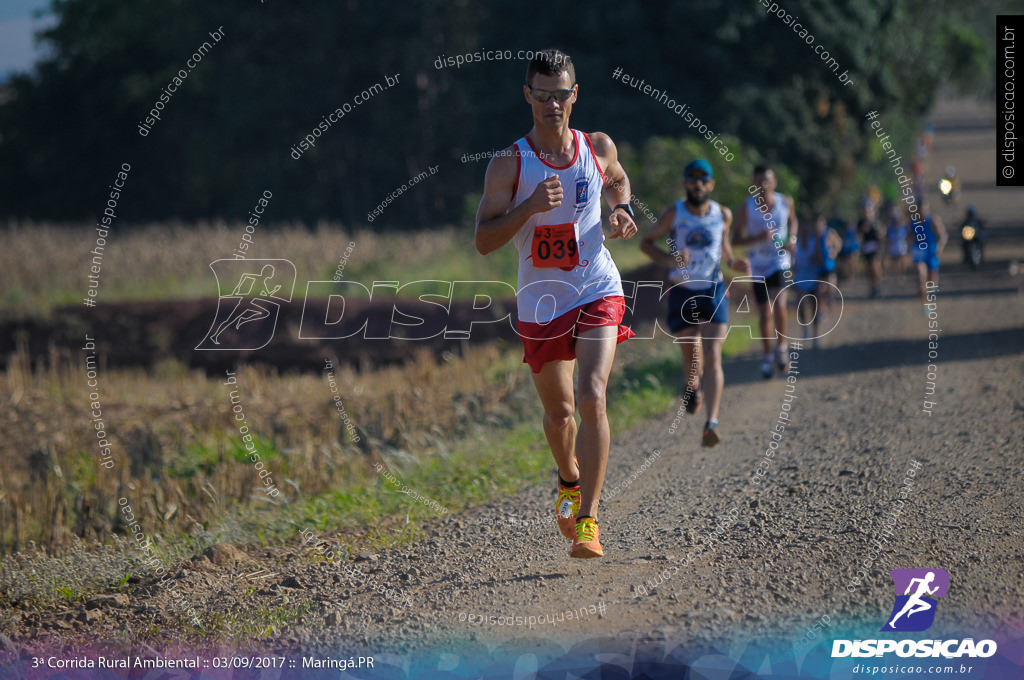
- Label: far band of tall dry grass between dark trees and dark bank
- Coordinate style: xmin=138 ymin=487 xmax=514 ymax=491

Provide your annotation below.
xmin=0 ymin=221 xmax=646 ymax=315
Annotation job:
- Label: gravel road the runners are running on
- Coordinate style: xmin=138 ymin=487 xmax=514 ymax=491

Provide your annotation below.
xmin=4 ymin=98 xmax=1024 ymax=675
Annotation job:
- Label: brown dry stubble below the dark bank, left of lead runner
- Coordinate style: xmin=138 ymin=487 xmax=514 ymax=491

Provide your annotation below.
xmin=0 ymin=346 xmax=528 ymax=550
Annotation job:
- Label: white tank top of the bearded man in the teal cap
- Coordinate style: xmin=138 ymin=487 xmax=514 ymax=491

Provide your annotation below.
xmin=669 ymin=199 xmax=725 ymax=290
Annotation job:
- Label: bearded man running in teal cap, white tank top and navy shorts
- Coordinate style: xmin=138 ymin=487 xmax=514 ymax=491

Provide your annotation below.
xmin=640 ymin=159 xmax=751 ymax=447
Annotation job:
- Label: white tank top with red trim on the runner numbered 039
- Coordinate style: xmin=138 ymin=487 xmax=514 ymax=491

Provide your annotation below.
xmin=512 ymin=130 xmax=623 ymax=324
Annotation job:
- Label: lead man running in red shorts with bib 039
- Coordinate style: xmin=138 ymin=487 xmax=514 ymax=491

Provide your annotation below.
xmin=476 ymin=49 xmax=637 ymax=557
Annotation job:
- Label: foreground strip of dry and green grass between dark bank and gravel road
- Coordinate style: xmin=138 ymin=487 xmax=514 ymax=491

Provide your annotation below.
xmin=0 ymin=323 xmax=712 ymax=630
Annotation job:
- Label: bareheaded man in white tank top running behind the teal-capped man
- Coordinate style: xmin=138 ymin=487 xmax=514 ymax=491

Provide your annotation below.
xmin=732 ymin=165 xmax=797 ymax=380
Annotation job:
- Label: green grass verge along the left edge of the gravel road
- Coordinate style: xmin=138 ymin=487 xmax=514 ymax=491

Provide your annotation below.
xmin=214 ymin=333 xmax=750 ymax=553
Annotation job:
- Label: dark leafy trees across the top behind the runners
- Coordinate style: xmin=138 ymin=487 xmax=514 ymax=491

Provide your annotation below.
xmin=0 ymin=0 xmax=1002 ymax=228
